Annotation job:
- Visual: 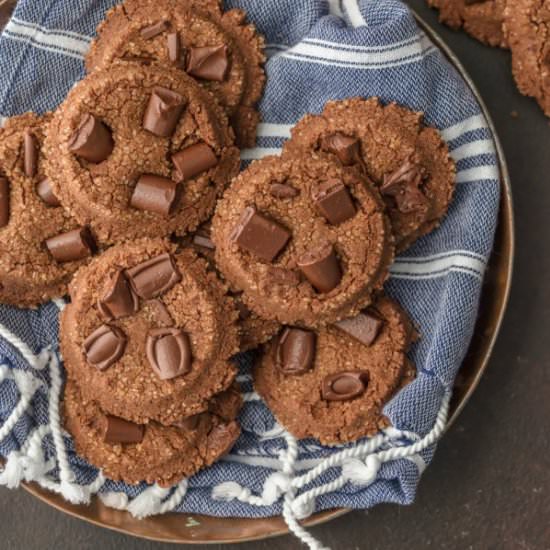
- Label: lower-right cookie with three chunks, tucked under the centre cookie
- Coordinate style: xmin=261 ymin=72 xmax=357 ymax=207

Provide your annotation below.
xmin=254 ymin=297 xmax=416 ymax=445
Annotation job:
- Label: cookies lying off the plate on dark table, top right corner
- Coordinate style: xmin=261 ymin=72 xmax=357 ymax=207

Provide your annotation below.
xmin=428 ymin=0 xmax=550 ymax=116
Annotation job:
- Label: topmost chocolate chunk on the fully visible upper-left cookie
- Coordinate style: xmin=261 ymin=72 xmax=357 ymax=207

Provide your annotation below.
xmin=143 ymin=86 xmax=185 ymax=137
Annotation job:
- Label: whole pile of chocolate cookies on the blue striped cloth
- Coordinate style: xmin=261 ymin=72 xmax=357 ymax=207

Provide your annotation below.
xmin=0 ymin=0 xmax=455 ymax=486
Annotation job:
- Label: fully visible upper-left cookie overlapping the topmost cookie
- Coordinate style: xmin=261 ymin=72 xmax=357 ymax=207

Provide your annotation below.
xmin=45 ymin=63 xmax=240 ymax=243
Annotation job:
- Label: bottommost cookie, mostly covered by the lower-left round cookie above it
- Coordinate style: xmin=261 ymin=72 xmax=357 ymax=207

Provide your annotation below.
xmin=63 ymin=381 xmax=241 ymax=487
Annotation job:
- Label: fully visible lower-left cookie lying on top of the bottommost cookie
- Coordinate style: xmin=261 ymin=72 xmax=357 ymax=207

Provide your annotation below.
xmin=60 ymin=239 xmax=239 ymax=424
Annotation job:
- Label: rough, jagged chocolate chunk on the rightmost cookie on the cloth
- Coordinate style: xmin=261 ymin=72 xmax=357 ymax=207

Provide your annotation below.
xmin=380 ymin=159 xmax=429 ymax=214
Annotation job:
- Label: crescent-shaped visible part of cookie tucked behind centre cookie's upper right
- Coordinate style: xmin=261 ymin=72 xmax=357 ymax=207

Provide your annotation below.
xmin=284 ymin=98 xmax=455 ymax=252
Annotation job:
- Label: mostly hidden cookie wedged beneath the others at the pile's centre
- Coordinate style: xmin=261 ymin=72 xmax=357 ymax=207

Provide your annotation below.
xmin=185 ymin=222 xmax=281 ymax=351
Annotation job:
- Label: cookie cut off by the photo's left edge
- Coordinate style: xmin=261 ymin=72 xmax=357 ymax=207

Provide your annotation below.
xmin=0 ymin=113 xmax=95 ymax=307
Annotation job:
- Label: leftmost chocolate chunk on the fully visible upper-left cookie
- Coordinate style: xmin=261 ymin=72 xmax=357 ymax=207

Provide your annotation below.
xmin=69 ymin=114 xmax=115 ymax=164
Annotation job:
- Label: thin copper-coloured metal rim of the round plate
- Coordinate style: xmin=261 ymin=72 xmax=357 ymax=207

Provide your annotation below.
xmin=11 ymin=8 xmax=515 ymax=545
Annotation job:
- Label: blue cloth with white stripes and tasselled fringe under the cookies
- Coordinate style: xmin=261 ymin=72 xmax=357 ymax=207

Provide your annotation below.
xmin=0 ymin=0 xmax=500 ymax=517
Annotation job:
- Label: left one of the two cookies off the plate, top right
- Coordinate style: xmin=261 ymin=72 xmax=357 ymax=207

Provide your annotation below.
xmin=428 ymin=0 xmax=516 ymax=48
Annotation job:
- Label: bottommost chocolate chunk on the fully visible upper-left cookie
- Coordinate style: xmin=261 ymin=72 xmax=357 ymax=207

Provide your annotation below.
xmin=130 ymin=174 xmax=178 ymax=216
